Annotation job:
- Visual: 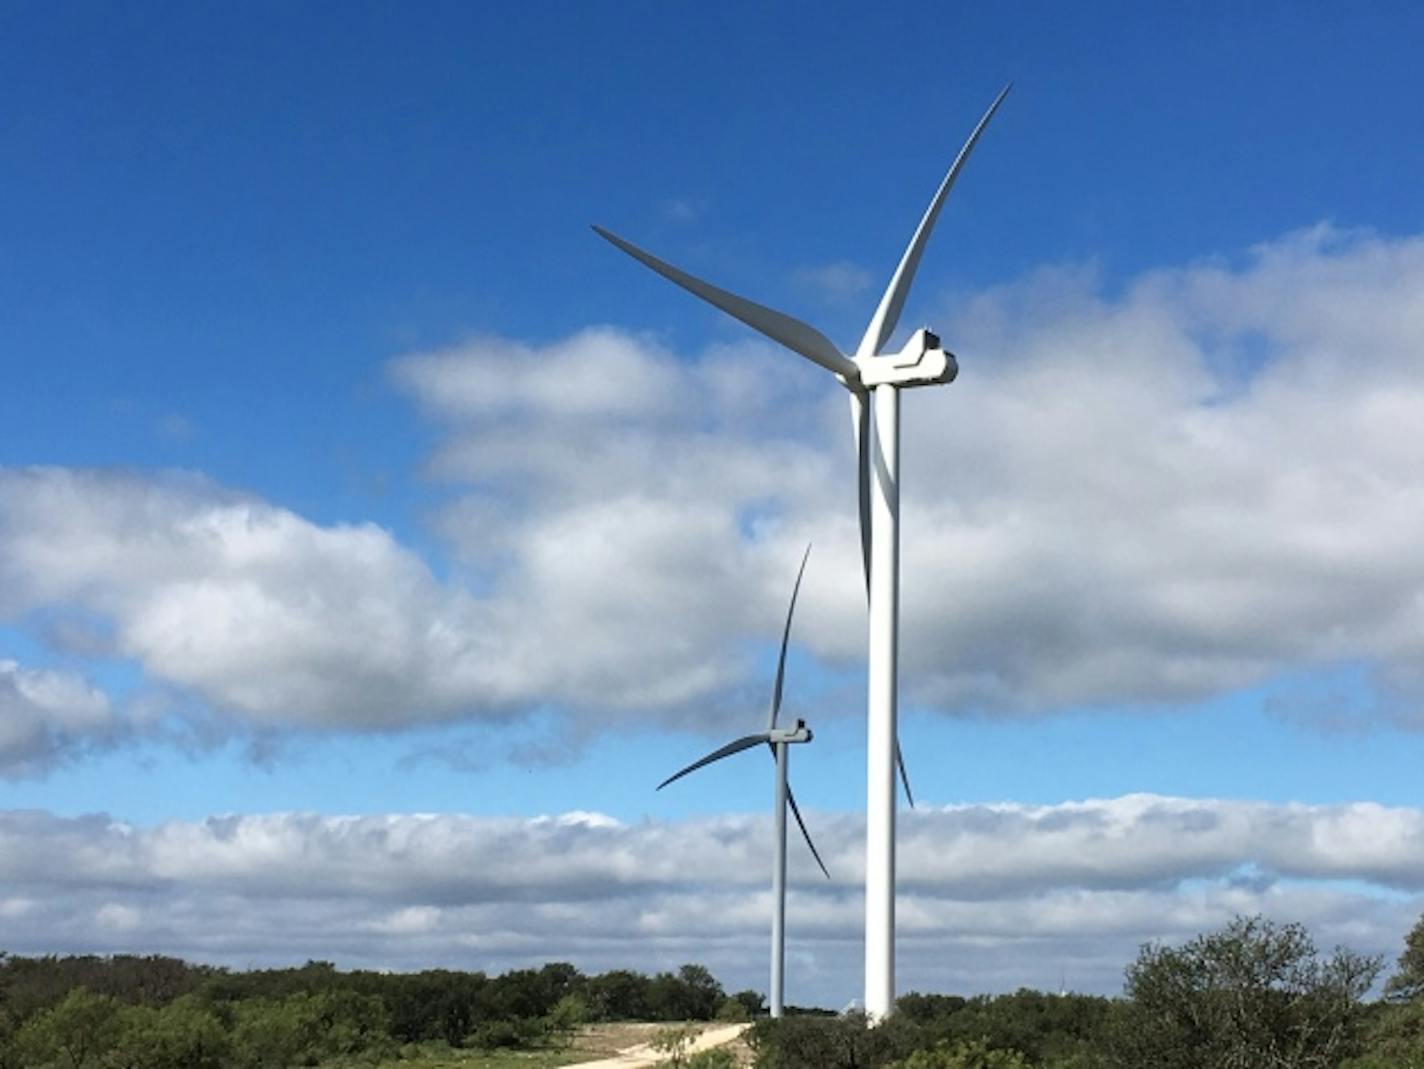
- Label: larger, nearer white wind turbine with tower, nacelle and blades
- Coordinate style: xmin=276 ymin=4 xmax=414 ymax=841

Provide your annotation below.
xmin=594 ymin=85 xmax=1010 ymax=1019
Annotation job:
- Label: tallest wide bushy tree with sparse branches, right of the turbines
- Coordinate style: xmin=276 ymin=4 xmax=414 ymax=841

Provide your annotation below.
xmin=1114 ymin=917 xmax=1380 ymax=1069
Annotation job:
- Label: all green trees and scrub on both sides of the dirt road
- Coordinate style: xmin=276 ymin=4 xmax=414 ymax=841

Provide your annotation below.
xmin=8 ymin=917 xmax=1424 ymax=1069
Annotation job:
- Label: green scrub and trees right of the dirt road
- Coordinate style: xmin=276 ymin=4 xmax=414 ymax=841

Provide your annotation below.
xmin=752 ymin=917 xmax=1424 ymax=1069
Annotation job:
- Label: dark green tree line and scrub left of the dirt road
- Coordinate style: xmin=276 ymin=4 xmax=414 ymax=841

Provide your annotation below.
xmin=0 ymin=952 xmax=765 ymax=1069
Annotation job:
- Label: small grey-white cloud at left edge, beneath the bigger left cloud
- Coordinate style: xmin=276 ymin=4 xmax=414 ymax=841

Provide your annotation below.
xmin=0 ymin=659 xmax=127 ymax=779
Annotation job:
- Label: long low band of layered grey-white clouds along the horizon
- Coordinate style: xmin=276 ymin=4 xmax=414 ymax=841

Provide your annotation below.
xmin=0 ymin=796 xmax=1424 ymax=1005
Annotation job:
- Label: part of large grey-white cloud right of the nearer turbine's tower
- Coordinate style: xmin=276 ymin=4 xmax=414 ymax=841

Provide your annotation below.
xmin=906 ymin=228 xmax=1424 ymax=713
